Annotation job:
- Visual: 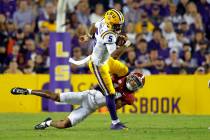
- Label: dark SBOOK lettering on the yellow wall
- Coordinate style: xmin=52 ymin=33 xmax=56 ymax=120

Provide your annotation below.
xmin=120 ymin=97 xmax=181 ymax=114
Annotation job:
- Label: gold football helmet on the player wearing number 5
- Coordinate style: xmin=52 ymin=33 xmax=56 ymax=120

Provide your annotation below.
xmin=104 ymin=9 xmax=124 ymax=32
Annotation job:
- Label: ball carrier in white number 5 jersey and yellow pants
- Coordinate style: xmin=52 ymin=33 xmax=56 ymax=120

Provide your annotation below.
xmin=70 ymin=9 xmax=130 ymax=129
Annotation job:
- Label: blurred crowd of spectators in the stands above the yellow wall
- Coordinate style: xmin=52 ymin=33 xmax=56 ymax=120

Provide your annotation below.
xmin=0 ymin=0 xmax=210 ymax=75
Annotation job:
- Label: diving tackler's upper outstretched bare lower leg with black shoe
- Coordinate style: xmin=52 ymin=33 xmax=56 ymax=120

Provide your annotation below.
xmin=11 ymin=87 xmax=60 ymax=102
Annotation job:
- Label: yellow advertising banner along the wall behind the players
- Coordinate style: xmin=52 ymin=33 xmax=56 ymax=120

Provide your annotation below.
xmin=0 ymin=74 xmax=210 ymax=115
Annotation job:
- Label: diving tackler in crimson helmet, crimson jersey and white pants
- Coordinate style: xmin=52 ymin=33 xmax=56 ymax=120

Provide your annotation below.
xmin=11 ymin=73 xmax=145 ymax=130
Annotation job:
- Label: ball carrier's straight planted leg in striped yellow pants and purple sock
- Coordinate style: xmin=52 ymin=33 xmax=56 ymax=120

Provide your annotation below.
xmin=89 ymin=62 xmax=126 ymax=129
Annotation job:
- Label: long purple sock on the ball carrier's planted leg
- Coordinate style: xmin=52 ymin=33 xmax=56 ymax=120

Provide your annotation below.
xmin=106 ymin=95 xmax=118 ymax=120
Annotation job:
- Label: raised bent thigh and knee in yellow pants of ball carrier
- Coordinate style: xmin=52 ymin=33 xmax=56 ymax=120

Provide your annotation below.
xmin=108 ymin=57 xmax=128 ymax=77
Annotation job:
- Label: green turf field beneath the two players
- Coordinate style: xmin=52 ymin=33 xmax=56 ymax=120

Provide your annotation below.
xmin=0 ymin=113 xmax=210 ymax=140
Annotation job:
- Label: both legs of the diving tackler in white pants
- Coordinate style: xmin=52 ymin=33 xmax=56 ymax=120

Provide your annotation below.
xmin=11 ymin=87 xmax=96 ymax=130
